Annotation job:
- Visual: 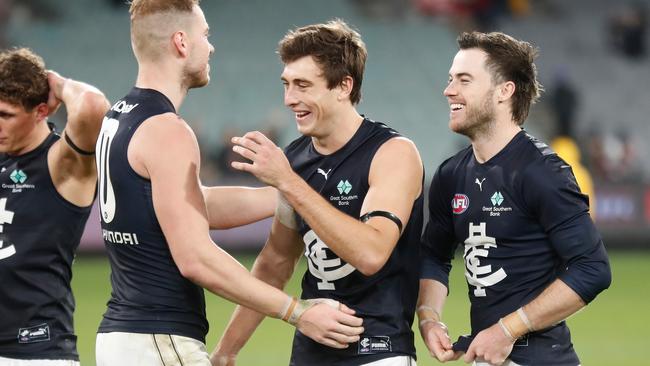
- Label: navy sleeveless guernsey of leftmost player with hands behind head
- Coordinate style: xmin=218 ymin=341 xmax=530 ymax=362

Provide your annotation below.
xmin=0 ymin=133 xmax=90 ymax=360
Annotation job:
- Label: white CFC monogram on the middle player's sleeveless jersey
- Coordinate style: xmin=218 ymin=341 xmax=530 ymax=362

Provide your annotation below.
xmin=302 ymin=230 xmax=355 ymax=290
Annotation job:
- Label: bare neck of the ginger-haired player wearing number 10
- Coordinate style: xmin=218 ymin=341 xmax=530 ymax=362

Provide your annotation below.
xmin=135 ymin=64 xmax=187 ymax=111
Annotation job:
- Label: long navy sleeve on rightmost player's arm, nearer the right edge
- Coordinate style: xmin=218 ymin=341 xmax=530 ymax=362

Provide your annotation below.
xmin=523 ymin=155 xmax=611 ymax=303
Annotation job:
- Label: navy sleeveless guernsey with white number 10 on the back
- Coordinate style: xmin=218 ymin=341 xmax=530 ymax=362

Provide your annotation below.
xmin=96 ymin=87 xmax=208 ymax=342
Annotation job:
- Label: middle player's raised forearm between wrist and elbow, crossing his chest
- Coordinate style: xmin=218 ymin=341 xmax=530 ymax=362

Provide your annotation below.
xmin=278 ymin=175 xmax=390 ymax=275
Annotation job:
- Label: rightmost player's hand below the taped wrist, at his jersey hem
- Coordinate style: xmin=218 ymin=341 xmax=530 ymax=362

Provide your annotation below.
xmin=463 ymin=323 xmax=514 ymax=365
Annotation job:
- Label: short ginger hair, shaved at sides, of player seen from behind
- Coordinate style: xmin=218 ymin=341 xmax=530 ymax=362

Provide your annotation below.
xmin=129 ymin=0 xmax=200 ymax=59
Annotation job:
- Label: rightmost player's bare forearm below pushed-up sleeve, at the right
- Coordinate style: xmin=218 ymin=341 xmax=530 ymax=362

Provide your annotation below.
xmin=503 ymin=280 xmax=586 ymax=338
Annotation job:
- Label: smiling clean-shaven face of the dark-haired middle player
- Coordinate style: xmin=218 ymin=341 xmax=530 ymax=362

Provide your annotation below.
xmin=282 ymin=56 xmax=342 ymax=137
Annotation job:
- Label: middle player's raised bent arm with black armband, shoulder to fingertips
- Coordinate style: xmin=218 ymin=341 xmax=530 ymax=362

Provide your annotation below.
xmin=233 ymin=132 xmax=423 ymax=275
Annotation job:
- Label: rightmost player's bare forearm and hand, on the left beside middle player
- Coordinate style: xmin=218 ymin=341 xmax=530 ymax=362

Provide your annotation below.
xmin=416 ymin=279 xmax=461 ymax=362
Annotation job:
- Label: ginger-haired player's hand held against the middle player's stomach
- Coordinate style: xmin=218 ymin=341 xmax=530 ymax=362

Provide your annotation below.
xmin=296 ymin=299 xmax=363 ymax=348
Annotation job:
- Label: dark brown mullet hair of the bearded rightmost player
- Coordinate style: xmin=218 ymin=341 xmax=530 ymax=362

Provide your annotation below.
xmin=457 ymin=32 xmax=544 ymax=126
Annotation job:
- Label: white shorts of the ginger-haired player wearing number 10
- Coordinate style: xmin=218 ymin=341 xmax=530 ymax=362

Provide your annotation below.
xmin=95 ymin=332 xmax=211 ymax=366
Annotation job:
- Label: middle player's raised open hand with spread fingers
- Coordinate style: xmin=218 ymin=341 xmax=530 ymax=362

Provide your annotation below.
xmin=231 ymin=131 xmax=295 ymax=187
